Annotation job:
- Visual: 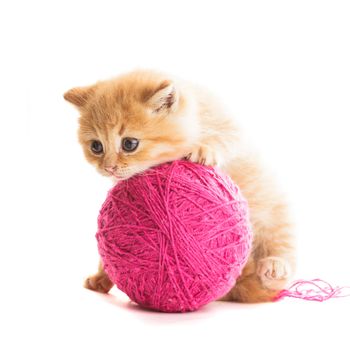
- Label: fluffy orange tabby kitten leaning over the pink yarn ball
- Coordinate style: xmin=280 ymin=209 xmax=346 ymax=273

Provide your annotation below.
xmin=64 ymin=71 xmax=295 ymax=302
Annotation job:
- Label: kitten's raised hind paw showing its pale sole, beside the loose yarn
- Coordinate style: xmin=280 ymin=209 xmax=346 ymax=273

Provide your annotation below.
xmin=256 ymin=256 xmax=291 ymax=290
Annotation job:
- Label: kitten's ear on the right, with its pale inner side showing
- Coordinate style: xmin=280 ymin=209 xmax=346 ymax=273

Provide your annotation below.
xmin=147 ymin=80 xmax=178 ymax=113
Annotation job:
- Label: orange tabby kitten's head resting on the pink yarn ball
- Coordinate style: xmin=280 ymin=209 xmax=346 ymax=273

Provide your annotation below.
xmin=64 ymin=71 xmax=198 ymax=180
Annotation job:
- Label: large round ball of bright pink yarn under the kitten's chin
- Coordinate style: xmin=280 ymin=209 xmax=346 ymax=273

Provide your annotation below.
xmin=96 ymin=161 xmax=251 ymax=312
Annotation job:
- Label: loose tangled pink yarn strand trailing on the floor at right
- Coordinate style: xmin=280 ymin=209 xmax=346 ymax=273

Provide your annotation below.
xmin=274 ymin=278 xmax=350 ymax=302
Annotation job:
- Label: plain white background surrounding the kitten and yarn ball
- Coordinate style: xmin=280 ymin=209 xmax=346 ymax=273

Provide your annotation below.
xmin=0 ymin=0 xmax=350 ymax=349
